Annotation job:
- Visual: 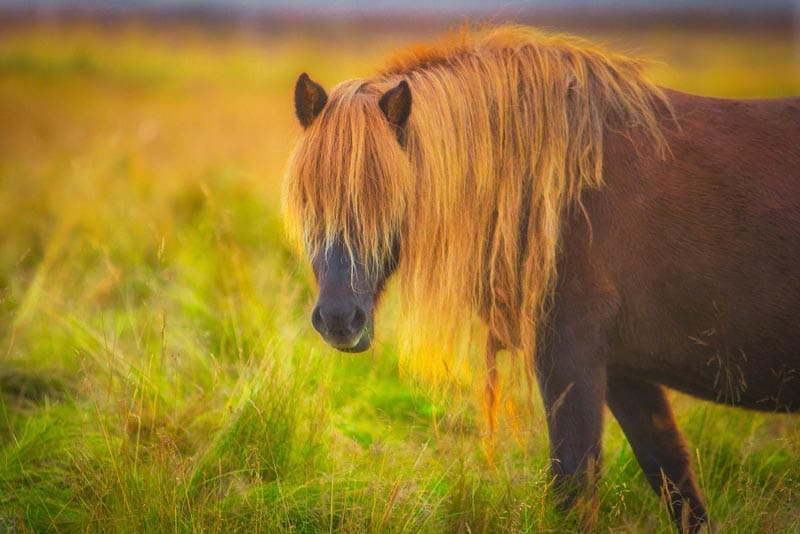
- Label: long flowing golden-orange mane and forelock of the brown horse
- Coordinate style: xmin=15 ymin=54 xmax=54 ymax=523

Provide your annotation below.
xmin=285 ymin=26 xmax=668 ymax=390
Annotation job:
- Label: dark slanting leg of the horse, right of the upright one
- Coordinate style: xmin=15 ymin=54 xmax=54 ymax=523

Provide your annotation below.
xmin=606 ymin=372 xmax=706 ymax=532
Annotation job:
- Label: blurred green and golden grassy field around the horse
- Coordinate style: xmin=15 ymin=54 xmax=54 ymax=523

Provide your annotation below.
xmin=0 ymin=18 xmax=800 ymax=533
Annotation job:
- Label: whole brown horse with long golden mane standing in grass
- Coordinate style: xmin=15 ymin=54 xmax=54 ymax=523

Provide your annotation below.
xmin=284 ymin=25 xmax=800 ymax=532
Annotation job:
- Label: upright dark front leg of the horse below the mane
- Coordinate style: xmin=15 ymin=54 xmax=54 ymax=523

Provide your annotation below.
xmin=536 ymin=321 xmax=606 ymax=512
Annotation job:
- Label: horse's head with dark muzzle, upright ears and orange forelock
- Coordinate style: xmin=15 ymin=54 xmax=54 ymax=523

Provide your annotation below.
xmin=286 ymin=74 xmax=411 ymax=352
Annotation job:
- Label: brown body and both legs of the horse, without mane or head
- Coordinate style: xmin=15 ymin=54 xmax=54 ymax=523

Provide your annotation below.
xmin=537 ymin=92 xmax=800 ymax=529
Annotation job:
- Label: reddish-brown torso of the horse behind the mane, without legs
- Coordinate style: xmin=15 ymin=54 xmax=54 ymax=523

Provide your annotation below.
xmin=588 ymin=92 xmax=800 ymax=411
